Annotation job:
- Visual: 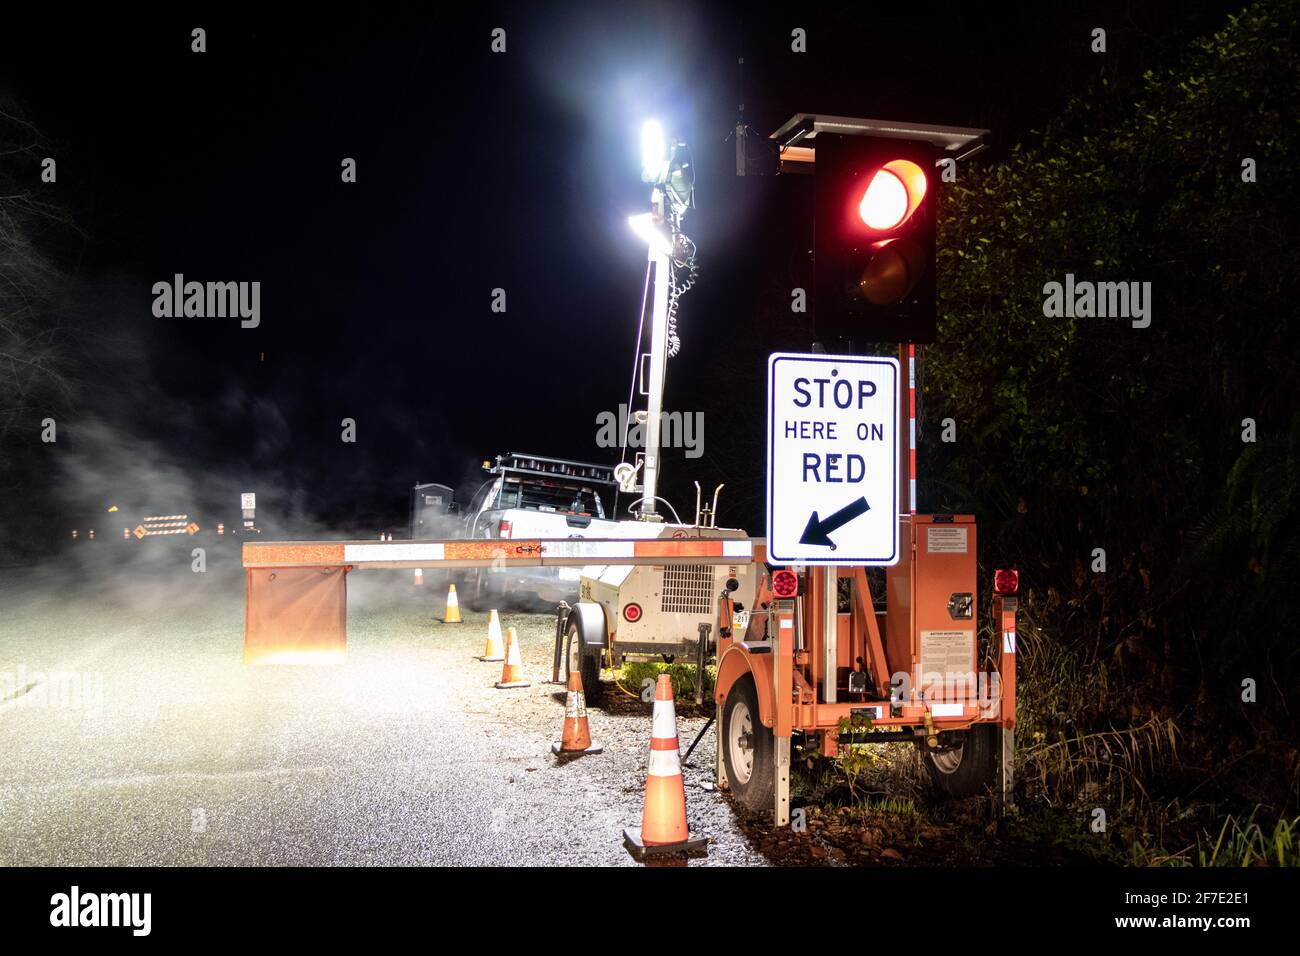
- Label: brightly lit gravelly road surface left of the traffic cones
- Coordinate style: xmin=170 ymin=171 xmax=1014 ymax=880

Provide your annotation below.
xmin=0 ymin=550 xmax=764 ymax=866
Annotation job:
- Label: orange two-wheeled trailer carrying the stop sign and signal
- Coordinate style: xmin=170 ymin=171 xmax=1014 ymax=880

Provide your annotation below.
xmin=715 ymin=346 xmax=1018 ymax=826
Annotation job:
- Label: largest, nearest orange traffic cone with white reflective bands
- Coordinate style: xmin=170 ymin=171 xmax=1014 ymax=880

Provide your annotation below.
xmin=623 ymin=674 xmax=709 ymax=860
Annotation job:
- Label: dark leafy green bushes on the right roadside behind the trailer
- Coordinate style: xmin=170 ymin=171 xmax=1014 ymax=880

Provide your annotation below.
xmin=920 ymin=0 xmax=1300 ymax=799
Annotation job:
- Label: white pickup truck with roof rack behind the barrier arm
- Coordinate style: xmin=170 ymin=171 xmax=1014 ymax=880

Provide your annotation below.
xmin=462 ymin=453 xmax=619 ymax=609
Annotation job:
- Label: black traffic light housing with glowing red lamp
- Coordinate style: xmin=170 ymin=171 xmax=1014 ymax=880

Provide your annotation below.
xmin=813 ymin=131 xmax=937 ymax=351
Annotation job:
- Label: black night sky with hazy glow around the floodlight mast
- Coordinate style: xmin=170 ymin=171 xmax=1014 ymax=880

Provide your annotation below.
xmin=0 ymin=3 xmax=1232 ymax=527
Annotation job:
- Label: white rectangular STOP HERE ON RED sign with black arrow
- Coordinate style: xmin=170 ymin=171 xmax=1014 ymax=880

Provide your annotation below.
xmin=767 ymin=352 xmax=898 ymax=566
